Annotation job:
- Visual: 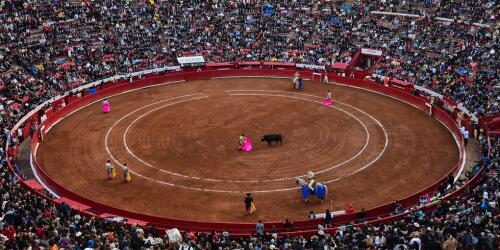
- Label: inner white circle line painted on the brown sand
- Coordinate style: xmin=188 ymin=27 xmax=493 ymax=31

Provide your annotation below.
xmin=122 ymin=91 xmax=370 ymax=183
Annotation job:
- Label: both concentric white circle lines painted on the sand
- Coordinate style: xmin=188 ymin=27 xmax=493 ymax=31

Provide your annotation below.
xmin=105 ymin=90 xmax=388 ymax=193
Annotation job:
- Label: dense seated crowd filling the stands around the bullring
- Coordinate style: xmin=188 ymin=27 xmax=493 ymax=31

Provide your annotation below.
xmin=0 ymin=0 xmax=500 ymax=250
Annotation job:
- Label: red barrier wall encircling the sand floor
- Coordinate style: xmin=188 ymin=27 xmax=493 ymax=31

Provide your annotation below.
xmin=5 ymin=68 xmax=470 ymax=235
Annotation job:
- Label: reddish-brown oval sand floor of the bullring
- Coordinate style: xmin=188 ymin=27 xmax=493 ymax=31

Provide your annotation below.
xmin=31 ymin=70 xmax=460 ymax=229
